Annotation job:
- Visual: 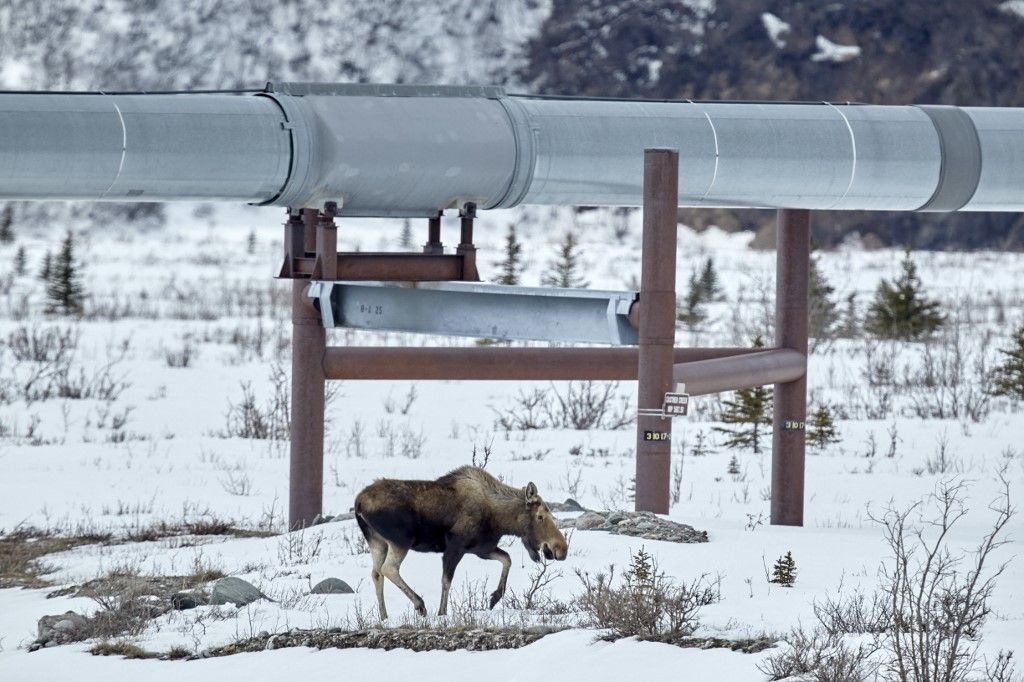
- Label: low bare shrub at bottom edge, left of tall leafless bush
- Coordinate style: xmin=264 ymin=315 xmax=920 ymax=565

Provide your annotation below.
xmin=758 ymin=628 xmax=878 ymax=682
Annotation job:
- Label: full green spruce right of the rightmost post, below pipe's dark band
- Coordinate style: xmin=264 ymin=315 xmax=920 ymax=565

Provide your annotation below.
xmin=864 ymin=250 xmax=945 ymax=340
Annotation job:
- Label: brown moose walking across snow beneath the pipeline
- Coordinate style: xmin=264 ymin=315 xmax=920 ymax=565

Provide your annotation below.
xmin=355 ymin=466 xmax=568 ymax=621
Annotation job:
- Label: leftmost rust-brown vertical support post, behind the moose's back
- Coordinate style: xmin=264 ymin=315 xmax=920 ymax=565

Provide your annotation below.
xmin=288 ymin=210 xmax=327 ymax=529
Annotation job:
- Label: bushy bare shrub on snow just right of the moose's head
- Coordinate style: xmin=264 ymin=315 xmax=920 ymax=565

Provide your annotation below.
xmin=577 ymin=548 xmax=722 ymax=642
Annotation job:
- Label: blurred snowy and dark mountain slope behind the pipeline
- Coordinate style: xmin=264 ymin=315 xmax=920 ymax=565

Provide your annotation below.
xmin=0 ymin=0 xmax=1024 ymax=249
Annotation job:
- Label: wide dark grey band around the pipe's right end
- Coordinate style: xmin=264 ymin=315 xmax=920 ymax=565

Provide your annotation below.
xmin=916 ymin=104 xmax=982 ymax=212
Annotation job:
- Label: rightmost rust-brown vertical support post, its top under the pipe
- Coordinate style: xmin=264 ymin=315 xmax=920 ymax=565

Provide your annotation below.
xmin=771 ymin=209 xmax=811 ymax=525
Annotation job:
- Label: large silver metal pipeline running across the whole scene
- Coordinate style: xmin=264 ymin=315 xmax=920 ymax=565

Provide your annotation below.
xmin=0 ymin=84 xmax=1024 ymax=216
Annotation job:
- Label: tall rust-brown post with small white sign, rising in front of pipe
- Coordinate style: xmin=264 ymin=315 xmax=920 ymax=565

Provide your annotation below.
xmin=636 ymin=150 xmax=679 ymax=514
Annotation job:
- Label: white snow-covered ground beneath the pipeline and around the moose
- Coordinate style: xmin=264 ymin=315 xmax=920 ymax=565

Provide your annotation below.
xmin=0 ymin=206 xmax=1024 ymax=681
